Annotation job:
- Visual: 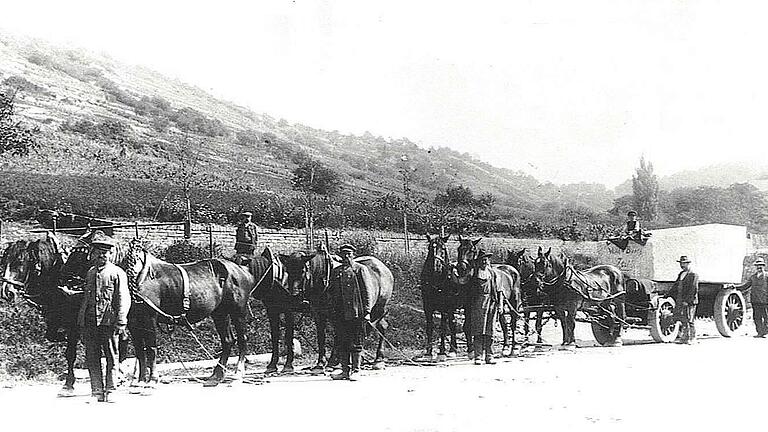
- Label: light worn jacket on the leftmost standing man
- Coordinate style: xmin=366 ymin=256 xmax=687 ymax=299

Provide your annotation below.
xmin=77 ymin=262 xmax=131 ymax=327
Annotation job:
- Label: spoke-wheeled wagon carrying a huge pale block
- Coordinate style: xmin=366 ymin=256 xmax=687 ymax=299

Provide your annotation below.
xmin=590 ymin=224 xmax=747 ymax=345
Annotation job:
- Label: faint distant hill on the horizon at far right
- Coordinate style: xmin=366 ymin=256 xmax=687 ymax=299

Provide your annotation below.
xmin=614 ymin=161 xmax=768 ymax=196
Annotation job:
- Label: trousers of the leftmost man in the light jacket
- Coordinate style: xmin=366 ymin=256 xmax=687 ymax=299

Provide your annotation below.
xmin=83 ymin=326 xmax=118 ymax=394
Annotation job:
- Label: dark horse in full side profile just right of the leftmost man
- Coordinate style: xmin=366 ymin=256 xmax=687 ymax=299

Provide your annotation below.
xmin=126 ymin=241 xmax=260 ymax=385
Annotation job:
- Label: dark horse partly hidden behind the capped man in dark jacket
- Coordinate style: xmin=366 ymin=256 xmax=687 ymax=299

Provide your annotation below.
xmin=282 ymin=249 xmax=394 ymax=371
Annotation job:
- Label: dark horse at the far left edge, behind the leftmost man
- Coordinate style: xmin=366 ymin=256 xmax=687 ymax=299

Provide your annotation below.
xmin=0 ymin=236 xmax=127 ymax=396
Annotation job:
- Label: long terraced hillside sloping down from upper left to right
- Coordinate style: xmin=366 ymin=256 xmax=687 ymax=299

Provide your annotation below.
xmin=0 ymin=34 xmax=613 ymax=226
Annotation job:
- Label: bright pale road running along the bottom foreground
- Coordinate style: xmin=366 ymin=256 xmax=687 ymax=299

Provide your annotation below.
xmin=0 ymin=322 xmax=768 ymax=432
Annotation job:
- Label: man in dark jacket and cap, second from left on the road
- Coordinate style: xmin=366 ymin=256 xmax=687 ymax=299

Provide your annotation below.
xmin=329 ymin=244 xmax=371 ymax=380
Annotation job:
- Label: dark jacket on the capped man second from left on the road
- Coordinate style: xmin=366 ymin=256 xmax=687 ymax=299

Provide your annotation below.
xmin=329 ymin=261 xmax=371 ymax=320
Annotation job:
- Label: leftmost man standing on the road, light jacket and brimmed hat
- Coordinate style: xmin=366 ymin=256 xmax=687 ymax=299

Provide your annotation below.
xmin=78 ymin=232 xmax=131 ymax=402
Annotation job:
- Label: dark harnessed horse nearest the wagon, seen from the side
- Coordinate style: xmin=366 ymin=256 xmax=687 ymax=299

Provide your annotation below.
xmin=535 ymin=247 xmax=626 ymax=346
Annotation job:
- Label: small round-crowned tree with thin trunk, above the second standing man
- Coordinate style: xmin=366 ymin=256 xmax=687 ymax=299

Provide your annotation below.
xmin=291 ymin=153 xmax=341 ymax=247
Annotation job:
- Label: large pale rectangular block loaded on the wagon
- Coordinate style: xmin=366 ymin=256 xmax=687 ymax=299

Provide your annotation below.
xmin=598 ymin=224 xmax=747 ymax=283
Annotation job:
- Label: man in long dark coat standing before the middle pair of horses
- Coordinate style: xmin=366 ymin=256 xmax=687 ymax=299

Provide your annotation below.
xmin=470 ymin=249 xmax=501 ymax=365
